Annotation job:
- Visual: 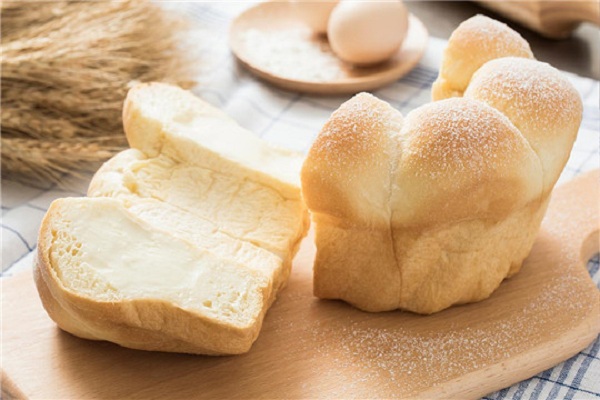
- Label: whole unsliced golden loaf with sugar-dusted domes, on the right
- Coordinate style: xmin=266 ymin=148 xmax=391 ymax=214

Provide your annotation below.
xmin=302 ymin=16 xmax=582 ymax=314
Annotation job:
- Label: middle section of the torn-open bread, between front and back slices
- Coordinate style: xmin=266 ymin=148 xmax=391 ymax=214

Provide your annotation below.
xmin=88 ymin=149 xmax=306 ymax=263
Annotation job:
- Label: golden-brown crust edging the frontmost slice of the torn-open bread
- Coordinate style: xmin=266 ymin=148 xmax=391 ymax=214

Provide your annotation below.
xmin=34 ymin=200 xmax=266 ymax=355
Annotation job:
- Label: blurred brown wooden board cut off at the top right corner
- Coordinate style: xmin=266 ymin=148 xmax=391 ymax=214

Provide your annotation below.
xmin=477 ymin=0 xmax=600 ymax=39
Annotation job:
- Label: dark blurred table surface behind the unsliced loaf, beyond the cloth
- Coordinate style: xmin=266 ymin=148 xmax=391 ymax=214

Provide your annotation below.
xmin=405 ymin=0 xmax=600 ymax=80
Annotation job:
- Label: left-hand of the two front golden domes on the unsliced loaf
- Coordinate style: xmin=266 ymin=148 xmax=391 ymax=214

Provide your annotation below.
xmin=301 ymin=93 xmax=402 ymax=226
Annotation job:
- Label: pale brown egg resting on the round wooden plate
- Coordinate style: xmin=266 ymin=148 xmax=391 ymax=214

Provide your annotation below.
xmin=327 ymin=0 xmax=408 ymax=65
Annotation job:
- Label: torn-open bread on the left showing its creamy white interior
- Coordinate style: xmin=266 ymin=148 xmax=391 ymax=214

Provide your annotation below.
xmin=35 ymin=84 xmax=308 ymax=354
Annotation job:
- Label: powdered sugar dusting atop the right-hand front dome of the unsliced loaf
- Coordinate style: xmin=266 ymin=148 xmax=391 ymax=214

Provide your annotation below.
xmin=403 ymin=98 xmax=533 ymax=179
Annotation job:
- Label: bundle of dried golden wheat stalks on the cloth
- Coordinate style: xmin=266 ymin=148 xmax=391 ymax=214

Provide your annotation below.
xmin=1 ymin=0 xmax=192 ymax=188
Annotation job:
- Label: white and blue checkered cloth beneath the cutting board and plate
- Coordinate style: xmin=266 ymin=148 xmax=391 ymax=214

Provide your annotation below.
xmin=1 ymin=2 xmax=600 ymax=399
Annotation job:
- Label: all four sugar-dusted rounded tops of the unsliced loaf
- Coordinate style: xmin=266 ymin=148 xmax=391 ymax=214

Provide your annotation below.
xmin=302 ymin=16 xmax=582 ymax=231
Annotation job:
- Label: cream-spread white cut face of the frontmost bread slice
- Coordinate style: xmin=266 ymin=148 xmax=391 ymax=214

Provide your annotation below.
xmin=50 ymin=198 xmax=269 ymax=326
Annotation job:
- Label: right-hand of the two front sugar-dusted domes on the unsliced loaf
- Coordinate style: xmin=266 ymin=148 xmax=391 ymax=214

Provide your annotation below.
xmin=391 ymin=98 xmax=541 ymax=226
